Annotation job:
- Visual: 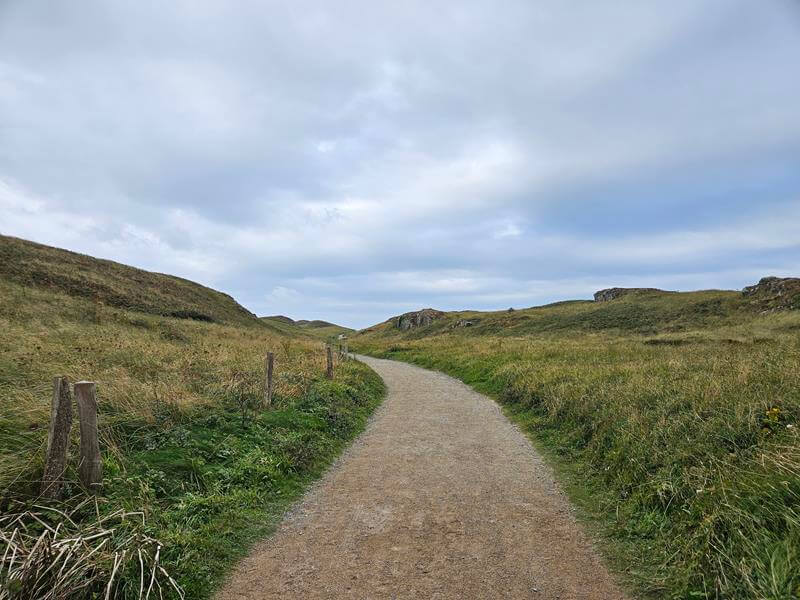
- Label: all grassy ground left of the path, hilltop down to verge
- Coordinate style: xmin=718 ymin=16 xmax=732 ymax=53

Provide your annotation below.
xmin=0 ymin=238 xmax=383 ymax=599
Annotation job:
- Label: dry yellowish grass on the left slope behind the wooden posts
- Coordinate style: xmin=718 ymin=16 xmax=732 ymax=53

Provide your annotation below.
xmin=0 ymin=282 xmax=324 ymax=496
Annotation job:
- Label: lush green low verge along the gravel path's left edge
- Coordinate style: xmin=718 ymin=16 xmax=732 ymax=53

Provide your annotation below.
xmin=106 ymin=361 xmax=383 ymax=598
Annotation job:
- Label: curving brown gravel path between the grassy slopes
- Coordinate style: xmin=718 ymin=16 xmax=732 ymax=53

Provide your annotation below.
xmin=217 ymin=358 xmax=624 ymax=600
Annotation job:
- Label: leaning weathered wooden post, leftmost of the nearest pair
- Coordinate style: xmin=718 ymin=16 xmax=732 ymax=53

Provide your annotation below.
xmin=41 ymin=377 xmax=72 ymax=499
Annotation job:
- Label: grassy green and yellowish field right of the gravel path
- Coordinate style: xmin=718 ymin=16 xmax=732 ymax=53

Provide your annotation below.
xmin=351 ymin=291 xmax=800 ymax=599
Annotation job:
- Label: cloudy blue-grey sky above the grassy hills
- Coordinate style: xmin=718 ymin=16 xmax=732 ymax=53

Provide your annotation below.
xmin=0 ymin=0 xmax=800 ymax=327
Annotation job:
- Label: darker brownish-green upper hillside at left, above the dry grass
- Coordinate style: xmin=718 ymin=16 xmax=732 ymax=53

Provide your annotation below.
xmin=0 ymin=235 xmax=268 ymax=326
